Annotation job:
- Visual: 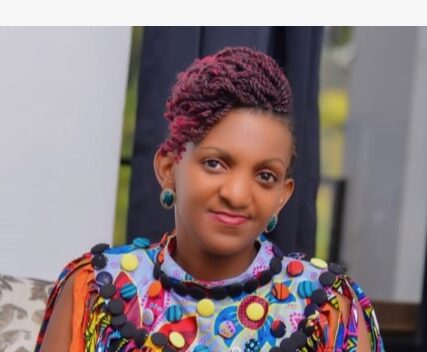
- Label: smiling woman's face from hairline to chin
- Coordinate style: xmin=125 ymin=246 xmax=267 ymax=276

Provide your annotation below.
xmin=156 ymin=109 xmax=293 ymax=256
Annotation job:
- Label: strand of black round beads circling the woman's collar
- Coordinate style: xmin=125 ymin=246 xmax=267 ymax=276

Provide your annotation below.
xmin=153 ymin=237 xmax=283 ymax=301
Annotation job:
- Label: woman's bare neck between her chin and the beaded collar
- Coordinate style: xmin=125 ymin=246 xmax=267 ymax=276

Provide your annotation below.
xmin=172 ymin=237 xmax=257 ymax=281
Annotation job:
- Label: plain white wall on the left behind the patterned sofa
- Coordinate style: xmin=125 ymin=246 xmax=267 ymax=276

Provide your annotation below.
xmin=0 ymin=27 xmax=131 ymax=280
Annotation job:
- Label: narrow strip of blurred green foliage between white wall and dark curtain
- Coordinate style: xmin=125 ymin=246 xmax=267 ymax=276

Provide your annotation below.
xmin=113 ymin=27 xmax=143 ymax=246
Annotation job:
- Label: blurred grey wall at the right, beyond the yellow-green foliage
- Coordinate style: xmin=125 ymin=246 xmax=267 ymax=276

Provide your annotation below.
xmin=341 ymin=27 xmax=427 ymax=302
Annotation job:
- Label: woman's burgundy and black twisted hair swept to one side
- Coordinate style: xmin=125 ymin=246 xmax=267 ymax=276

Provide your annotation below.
xmin=159 ymin=47 xmax=295 ymax=175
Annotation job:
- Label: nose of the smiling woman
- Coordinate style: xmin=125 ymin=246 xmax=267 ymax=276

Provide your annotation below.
xmin=219 ymin=173 xmax=252 ymax=209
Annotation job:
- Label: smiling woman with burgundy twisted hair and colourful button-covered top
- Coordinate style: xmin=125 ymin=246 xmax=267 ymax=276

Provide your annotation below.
xmin=36 ymin=48 xmax=383 ymax=352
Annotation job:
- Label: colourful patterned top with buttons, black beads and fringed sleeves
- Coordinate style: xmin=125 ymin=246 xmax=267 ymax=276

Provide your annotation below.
xmin=35 ymin=235 xmax=384 ymax=352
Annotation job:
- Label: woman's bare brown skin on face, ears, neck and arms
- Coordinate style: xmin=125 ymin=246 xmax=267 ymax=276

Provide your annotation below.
xmin=41 ymin=109 xmax=370 ymax=352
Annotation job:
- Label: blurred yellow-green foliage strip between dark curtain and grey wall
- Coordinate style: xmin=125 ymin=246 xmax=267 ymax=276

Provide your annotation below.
xmin=316 ymin=27 xmax=353 ymax=260
